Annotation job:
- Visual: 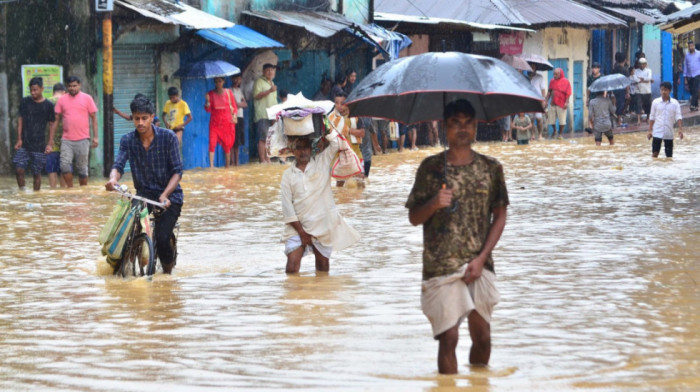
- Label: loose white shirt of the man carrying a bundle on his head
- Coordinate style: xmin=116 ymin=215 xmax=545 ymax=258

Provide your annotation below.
xmin=281 ymin=131 xmax=360 ymax=251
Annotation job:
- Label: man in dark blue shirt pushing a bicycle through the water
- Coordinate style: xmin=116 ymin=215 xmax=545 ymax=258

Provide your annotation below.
xmin=105 ymin=96 xmax=184 ymax=274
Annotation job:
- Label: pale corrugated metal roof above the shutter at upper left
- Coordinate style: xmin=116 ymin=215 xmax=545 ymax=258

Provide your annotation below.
xmin=114 ymin=0 xmax=234 ymax=30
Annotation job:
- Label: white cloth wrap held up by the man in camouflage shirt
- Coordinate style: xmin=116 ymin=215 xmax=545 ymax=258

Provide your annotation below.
xmin=421 ymin=264 xmax=500 ymax=339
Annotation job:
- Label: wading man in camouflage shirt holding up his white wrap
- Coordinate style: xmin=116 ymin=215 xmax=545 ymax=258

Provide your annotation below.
xmin=406 ymin=100 xmax=508 ymax=374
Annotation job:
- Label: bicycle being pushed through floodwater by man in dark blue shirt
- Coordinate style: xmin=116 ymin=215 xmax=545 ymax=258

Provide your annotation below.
xmin=114 ymin=185 xmax=180 ymax=278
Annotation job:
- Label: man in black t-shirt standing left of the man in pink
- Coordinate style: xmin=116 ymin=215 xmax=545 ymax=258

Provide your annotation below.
xmin=12 ymin=77 xmax=56 ymax=191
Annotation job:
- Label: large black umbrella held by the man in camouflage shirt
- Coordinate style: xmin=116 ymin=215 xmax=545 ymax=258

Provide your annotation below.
xmin=347 ymin=52 xmax=542 ymax=124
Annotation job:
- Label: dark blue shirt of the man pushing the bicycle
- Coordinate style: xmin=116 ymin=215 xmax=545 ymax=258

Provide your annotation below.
xmin=112 ymin=125 xmax=184 ymax=204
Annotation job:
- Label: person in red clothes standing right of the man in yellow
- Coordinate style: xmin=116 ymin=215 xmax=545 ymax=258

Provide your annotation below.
xmin=204 ymin=77 xmax=238 ymax=168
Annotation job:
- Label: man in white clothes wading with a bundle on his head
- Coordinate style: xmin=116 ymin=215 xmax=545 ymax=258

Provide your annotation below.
xmin=281 ymin=131 xmax=359 ymax=274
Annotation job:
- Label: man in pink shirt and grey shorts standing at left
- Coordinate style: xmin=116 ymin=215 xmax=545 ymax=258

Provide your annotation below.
xmin=51 ymin=76 xmax=100 ymax=188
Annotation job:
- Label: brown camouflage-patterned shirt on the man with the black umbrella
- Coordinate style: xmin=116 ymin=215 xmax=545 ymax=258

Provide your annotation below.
xmin=406 ymin=151 xmax=509 ymax=280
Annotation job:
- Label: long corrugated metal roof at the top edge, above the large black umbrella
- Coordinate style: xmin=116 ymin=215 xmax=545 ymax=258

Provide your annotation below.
xmin=375 ymin=0 xmax=627 ymax=26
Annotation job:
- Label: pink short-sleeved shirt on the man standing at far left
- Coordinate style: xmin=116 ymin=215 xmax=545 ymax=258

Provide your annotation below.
xmin=55 ymin=91 xmax=97 ymax=141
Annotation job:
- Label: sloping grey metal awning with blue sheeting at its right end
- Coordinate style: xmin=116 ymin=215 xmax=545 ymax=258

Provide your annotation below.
xmin=243 ymin=10 xmax=411 ymax=58
